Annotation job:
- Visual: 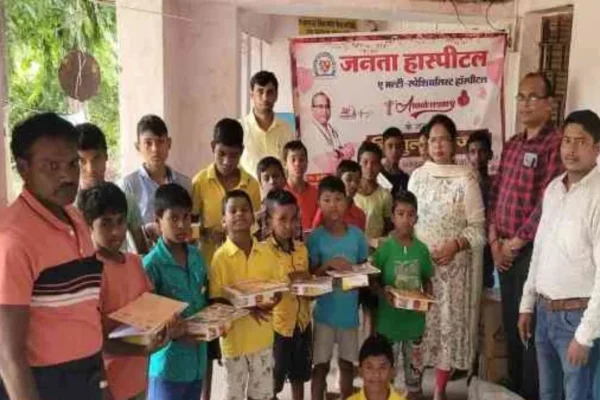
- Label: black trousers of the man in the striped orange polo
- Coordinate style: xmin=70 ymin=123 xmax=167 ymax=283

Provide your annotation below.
xmin=0 ymin=353 xmax=102 ymax=400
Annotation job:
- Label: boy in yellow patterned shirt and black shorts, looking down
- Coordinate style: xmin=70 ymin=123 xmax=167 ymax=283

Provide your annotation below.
xmin=263 ymin=189 xmax=312 ymax=400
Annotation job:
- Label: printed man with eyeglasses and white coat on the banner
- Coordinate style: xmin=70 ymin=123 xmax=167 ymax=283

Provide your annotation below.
xmin=302 ymin=92 xmax=355 ymax=174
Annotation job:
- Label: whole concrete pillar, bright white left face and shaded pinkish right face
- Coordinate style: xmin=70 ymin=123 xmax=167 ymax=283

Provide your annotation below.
xmin=117 ymin=0 xmax=240 ymax=176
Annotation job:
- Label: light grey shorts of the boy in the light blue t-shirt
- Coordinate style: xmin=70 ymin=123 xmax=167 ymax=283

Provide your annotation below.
xmin=313 ymin=322 xmax=358 ymax=365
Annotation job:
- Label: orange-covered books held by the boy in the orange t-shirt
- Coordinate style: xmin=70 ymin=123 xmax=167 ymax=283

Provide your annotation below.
xmin=108 ymin=292 xmax=188 ymax=346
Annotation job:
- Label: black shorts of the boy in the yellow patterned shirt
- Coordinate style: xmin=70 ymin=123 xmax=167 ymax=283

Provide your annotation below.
xmin=273 ymin=325 xmax=312 ymax=394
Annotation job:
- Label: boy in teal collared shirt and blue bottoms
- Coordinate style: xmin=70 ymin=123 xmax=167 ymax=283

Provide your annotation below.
xmin=143 ymin=183 xmax=208 ymax=400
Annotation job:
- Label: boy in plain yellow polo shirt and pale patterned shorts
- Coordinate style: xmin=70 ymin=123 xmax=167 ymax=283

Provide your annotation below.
xmin=209 ymin=190 xmax=281 ymax=400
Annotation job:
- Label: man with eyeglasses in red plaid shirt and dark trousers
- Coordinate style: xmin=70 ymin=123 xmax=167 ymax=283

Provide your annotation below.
xmin=488 ymin=73 xmax=564 ymax=400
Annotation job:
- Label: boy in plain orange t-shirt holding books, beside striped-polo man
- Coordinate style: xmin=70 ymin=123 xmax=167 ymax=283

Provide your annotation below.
xmin=78 ymin=182 xmax=166 ymax=400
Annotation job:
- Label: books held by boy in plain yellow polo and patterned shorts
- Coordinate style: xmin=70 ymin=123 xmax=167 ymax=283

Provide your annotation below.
xmin=224 ymin=281 xmax=289 ymax=308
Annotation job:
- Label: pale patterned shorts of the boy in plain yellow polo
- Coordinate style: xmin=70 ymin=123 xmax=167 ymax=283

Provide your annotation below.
xmin=224 ymin=347 xmax=273 ymax=400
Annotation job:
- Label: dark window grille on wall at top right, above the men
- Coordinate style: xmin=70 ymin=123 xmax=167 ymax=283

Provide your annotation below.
xmin=540 ymin=12 xmax=573 ymax=124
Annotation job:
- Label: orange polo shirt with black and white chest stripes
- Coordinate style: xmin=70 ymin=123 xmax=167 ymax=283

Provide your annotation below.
xmin=0 ymin=189 xmax=102 ymax=367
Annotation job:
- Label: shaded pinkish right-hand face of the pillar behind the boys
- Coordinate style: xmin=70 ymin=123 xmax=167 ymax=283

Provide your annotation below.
xmin=164 ymin=0 xmax=240 ymax=176
